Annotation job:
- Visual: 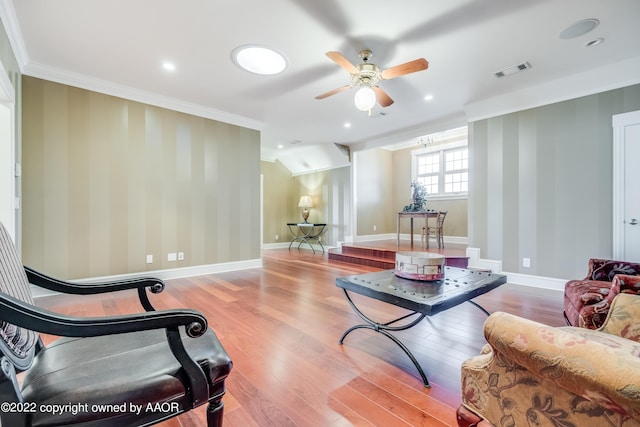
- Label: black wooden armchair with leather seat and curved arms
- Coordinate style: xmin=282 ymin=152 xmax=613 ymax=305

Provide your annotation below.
xmin=0 ymin=224 xmax=232 ymax=427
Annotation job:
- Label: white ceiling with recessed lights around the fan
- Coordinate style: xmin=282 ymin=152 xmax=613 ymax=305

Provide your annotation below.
xmin=0 ymin=0 xmax=640 ymax=174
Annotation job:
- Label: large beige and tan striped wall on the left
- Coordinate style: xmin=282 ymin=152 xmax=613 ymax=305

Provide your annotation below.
xmin=23 ymin=77 xmax=260 ymax=279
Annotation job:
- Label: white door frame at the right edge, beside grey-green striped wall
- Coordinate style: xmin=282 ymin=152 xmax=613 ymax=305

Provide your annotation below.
xmin=612 ymin=111 xmax=640 ymax=260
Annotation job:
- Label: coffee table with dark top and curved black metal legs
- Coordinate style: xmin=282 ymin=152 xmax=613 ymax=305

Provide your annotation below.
xmin=336 ymin=267 xmax=507 ymax=387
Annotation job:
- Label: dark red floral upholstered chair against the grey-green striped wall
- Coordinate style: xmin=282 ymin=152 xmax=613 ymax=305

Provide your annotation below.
xmin=564 ymin=258 xmax=640 ymax=329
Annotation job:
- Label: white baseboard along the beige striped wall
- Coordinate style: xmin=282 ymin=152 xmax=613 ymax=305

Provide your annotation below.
xmin=31 ymin=258 xmax=262 ymax=298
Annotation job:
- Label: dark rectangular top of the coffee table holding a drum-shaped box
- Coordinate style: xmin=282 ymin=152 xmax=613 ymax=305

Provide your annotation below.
xmin=336 ymin=267 xmax=507 ymax=315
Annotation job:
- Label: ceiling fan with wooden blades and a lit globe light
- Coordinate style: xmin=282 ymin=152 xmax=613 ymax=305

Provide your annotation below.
xmin=316 ymin=50 xmax=429 ymax=111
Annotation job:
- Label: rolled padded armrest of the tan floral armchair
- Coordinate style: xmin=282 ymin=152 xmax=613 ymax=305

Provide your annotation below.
xmin=484 ymin=312 xmax=640 ymax=413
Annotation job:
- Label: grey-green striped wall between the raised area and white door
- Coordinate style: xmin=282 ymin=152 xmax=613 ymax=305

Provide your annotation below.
xmin=469 ymin=85 xmax=640 ymax=279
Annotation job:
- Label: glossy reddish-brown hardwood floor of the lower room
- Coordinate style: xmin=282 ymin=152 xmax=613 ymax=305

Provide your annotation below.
xmin=36 ymin=249 xmax=564 ymax=427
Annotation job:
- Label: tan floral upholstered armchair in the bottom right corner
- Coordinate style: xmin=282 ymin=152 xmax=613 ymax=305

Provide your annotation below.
xmin=458 ymin=294 xmax=640 ymax=427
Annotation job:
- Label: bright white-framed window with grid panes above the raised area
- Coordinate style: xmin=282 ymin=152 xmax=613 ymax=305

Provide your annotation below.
xmin=412 ymin=138 xmax=469 ymax=197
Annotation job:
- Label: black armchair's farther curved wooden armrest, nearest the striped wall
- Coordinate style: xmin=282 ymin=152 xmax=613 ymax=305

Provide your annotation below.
xmin=24 ymin=265 xmax=164 ymax=311
